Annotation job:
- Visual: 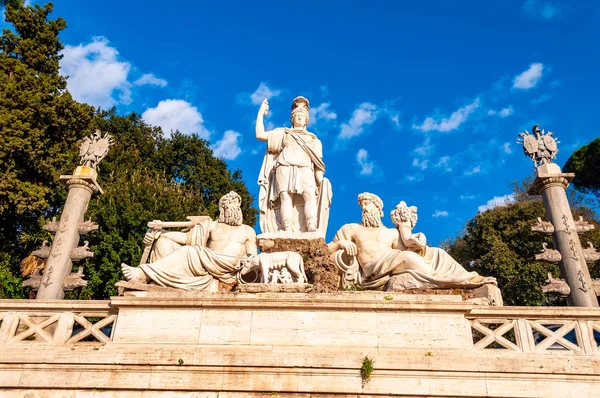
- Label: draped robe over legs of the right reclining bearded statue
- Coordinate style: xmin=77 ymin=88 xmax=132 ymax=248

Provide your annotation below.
xmin=332 ymin=225 xmax=491 ymax=289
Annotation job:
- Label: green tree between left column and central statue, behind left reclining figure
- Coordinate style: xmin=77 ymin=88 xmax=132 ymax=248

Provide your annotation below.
xmin=69 ymin=109 xmax=256 ymax=299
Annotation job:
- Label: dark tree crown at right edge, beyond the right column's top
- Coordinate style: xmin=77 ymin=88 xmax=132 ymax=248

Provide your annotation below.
xmin=564 ymin=138 xmax=600 ymax=197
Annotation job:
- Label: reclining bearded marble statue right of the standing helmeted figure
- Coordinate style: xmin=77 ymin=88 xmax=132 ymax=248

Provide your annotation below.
xmin=328 ymin=193 xmax=496 ymax=289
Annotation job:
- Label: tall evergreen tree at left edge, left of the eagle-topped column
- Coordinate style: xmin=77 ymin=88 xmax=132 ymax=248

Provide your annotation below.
xmin=0 ymin=1 xmax=93 ymax=296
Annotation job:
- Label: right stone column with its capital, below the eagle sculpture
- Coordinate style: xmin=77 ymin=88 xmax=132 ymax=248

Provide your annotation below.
xmin=529 ymin=163 xmax=598 ymax=307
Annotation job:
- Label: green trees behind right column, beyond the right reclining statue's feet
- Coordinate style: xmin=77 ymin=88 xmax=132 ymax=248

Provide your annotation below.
xmin=446 ymin=186 xmax=600 ymax=305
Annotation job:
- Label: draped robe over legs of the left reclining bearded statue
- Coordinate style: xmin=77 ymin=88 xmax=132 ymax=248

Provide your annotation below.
xmin=140 ymin=220 xmax=241 ymax=291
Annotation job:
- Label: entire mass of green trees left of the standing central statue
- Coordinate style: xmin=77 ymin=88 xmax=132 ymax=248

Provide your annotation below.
xmin=0 ymin=4 xmax=257 ymax=298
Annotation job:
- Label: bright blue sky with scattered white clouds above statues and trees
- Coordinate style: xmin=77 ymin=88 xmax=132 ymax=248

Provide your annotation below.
xmin=4 ymin=0 xmax=600 ymax=244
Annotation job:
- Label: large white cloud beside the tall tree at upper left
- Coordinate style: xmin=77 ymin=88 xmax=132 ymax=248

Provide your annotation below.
xmin=60 ymin=36 xmax=131 ymax=108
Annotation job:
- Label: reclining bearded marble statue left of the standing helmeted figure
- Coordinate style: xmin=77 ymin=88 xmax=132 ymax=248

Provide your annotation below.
xmin=121 ymin=192 xmax=257 ymax=291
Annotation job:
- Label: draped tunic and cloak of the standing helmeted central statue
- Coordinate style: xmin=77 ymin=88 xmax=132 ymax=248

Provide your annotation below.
xmin=258 ymin=128 xmax=332 ymax=233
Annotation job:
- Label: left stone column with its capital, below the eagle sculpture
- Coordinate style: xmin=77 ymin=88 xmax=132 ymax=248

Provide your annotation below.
xmin=36 ymin=166 xmax=101 ymax=300
